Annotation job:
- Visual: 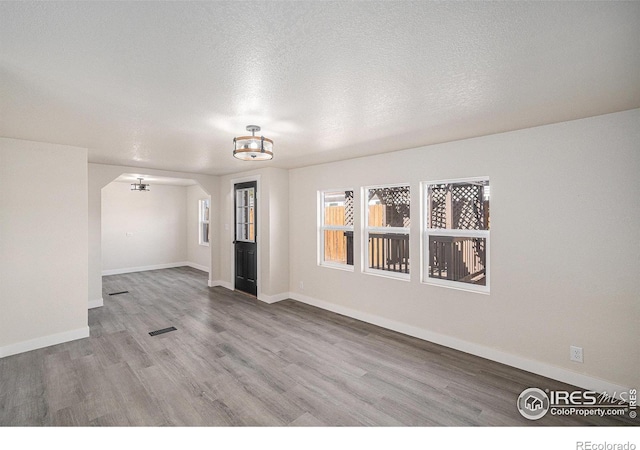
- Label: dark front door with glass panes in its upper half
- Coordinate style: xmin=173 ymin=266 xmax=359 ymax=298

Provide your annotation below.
xmin=234 ymin=181 xmax=258 ymax=295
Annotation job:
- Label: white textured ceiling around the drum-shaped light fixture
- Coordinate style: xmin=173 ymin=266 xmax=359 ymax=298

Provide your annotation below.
xmin=0 ymin=1 xmax=640 ymax=174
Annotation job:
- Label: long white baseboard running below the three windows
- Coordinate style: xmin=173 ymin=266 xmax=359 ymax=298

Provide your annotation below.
xmin=289 ymin=292 xmax=630 ymax=396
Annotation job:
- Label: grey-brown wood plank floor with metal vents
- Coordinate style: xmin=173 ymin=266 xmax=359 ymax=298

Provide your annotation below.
xmin=0 ymin=267 xmax=631 ymax=426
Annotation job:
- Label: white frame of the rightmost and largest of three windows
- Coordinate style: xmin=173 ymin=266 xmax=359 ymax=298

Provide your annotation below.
xmin=420 ymin=176 xmax=491 ymax=294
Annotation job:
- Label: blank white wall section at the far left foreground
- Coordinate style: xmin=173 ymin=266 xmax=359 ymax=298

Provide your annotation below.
xmin=0 ymin=138 xmax=89 ymax=357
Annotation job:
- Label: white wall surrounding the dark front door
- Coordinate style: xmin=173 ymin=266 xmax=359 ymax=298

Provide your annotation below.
xmin=216 ymin=168 xmax=289 ymax=302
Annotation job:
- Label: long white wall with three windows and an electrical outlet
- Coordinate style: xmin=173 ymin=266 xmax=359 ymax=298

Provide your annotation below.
xmin=289 ymin=110 xmax=640 ymax=388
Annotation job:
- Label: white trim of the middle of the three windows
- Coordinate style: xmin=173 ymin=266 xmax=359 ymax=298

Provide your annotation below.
xmin=360 ymin=182 xmax=411 ymax=281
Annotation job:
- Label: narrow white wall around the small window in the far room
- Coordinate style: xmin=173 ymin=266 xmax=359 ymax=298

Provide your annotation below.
xmin=187 ymin=184 xmax=212 ymax=271
